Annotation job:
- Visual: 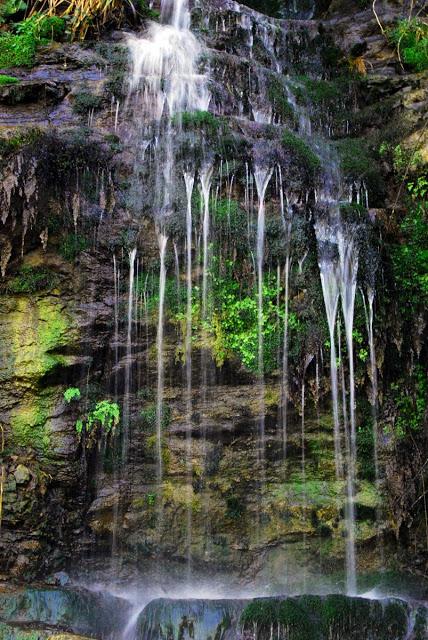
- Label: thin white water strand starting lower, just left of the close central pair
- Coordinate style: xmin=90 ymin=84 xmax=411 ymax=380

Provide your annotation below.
xmin=156 ymin=230 xmax=168 ymax=487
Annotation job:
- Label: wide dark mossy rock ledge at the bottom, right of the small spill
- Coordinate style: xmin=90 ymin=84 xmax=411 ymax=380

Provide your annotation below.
xmin=136 ymin=595 xmax=426 ymax=640
